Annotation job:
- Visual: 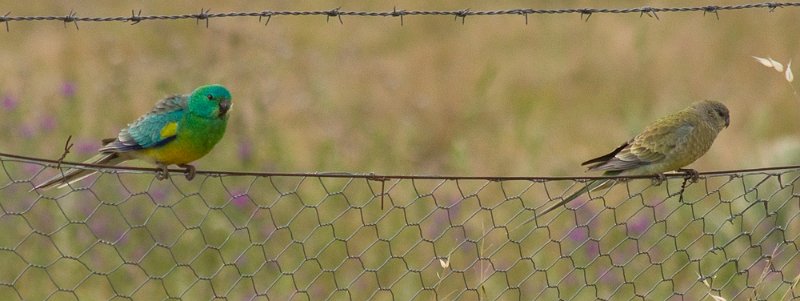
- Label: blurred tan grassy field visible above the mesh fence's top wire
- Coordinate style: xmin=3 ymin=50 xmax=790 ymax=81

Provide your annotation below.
xmin=0 ymin=1 xmax=800 ymax=176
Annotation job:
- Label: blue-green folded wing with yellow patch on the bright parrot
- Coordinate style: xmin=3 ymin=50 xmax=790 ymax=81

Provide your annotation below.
xmin=100 ymin=96 xmax=187 ymax=152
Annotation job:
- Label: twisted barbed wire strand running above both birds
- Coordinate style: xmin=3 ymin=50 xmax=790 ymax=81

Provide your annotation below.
xmin=0 ymin=2 xmax=800 ymax=31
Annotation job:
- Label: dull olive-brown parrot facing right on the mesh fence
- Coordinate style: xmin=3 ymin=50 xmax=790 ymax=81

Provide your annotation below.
xmin=525 ymin=100 xmax=730 ymax=224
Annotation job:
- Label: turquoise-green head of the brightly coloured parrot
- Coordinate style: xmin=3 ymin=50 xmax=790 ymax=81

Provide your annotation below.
xmin=188 ymin=85 xmax=231 ymax=119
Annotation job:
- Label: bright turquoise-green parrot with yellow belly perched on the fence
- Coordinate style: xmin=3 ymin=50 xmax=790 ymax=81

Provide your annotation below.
xmin=33 ymin=85 xmax=231 ymax=189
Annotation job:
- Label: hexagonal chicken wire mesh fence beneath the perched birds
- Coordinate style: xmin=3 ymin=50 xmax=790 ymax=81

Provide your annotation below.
xmin=0 ymin=156 xmax=800 ymax=300
